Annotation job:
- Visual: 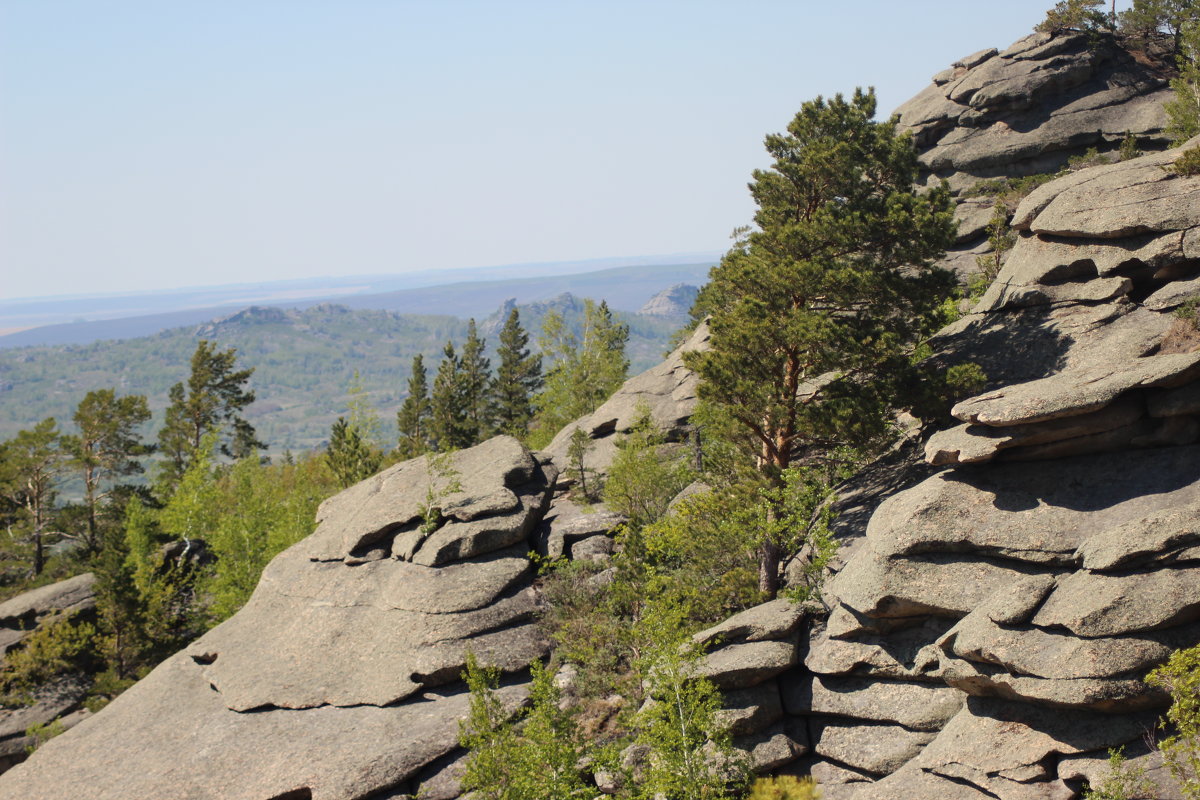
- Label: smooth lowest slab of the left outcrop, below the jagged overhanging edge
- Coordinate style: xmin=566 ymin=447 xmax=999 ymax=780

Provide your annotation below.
xmin=0 ymin=654 xmax=524 ymax=800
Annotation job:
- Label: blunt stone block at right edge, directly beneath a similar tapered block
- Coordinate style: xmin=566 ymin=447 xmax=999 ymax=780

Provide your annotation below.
xmin=1033 ymin=565 xmax=1200 ymax=637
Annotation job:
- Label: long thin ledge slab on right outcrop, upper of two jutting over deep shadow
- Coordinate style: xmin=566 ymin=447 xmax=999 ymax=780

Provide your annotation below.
xmin=950 ymin=353 xmax=1200 ymax=427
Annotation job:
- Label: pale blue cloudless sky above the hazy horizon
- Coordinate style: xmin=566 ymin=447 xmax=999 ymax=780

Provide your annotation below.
xmin=0 ymin=0 xmax=1128 ymax=299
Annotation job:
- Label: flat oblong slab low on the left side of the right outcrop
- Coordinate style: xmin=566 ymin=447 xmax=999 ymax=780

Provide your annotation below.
xmin=780 ymin=675 xmax=962 ymax=730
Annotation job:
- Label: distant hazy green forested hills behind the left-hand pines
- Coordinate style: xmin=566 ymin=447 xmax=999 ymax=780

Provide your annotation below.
xmin=0 ymin=295 xmax=682 ymax=452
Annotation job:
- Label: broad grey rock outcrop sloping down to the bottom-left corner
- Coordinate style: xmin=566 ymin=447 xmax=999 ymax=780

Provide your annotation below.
xmin=0 ymin=437 xmax=556 ymax=800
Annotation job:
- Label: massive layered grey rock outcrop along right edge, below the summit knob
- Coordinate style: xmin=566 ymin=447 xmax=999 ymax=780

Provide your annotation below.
xmin=763 ymin=140 xmax=1200 ymax=800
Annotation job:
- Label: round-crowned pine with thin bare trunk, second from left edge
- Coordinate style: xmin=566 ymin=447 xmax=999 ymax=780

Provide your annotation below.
xmin=62 ymin=389 xmax=150 ymax=553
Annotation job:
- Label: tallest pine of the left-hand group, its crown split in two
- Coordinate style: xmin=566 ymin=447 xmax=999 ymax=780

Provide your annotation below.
xmin=158 ymin=339 xmax=266 ymax=486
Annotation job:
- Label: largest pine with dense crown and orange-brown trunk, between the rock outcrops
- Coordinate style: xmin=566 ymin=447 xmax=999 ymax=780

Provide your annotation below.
xmin=684 ymin=90 xmax=955 ymax=595
